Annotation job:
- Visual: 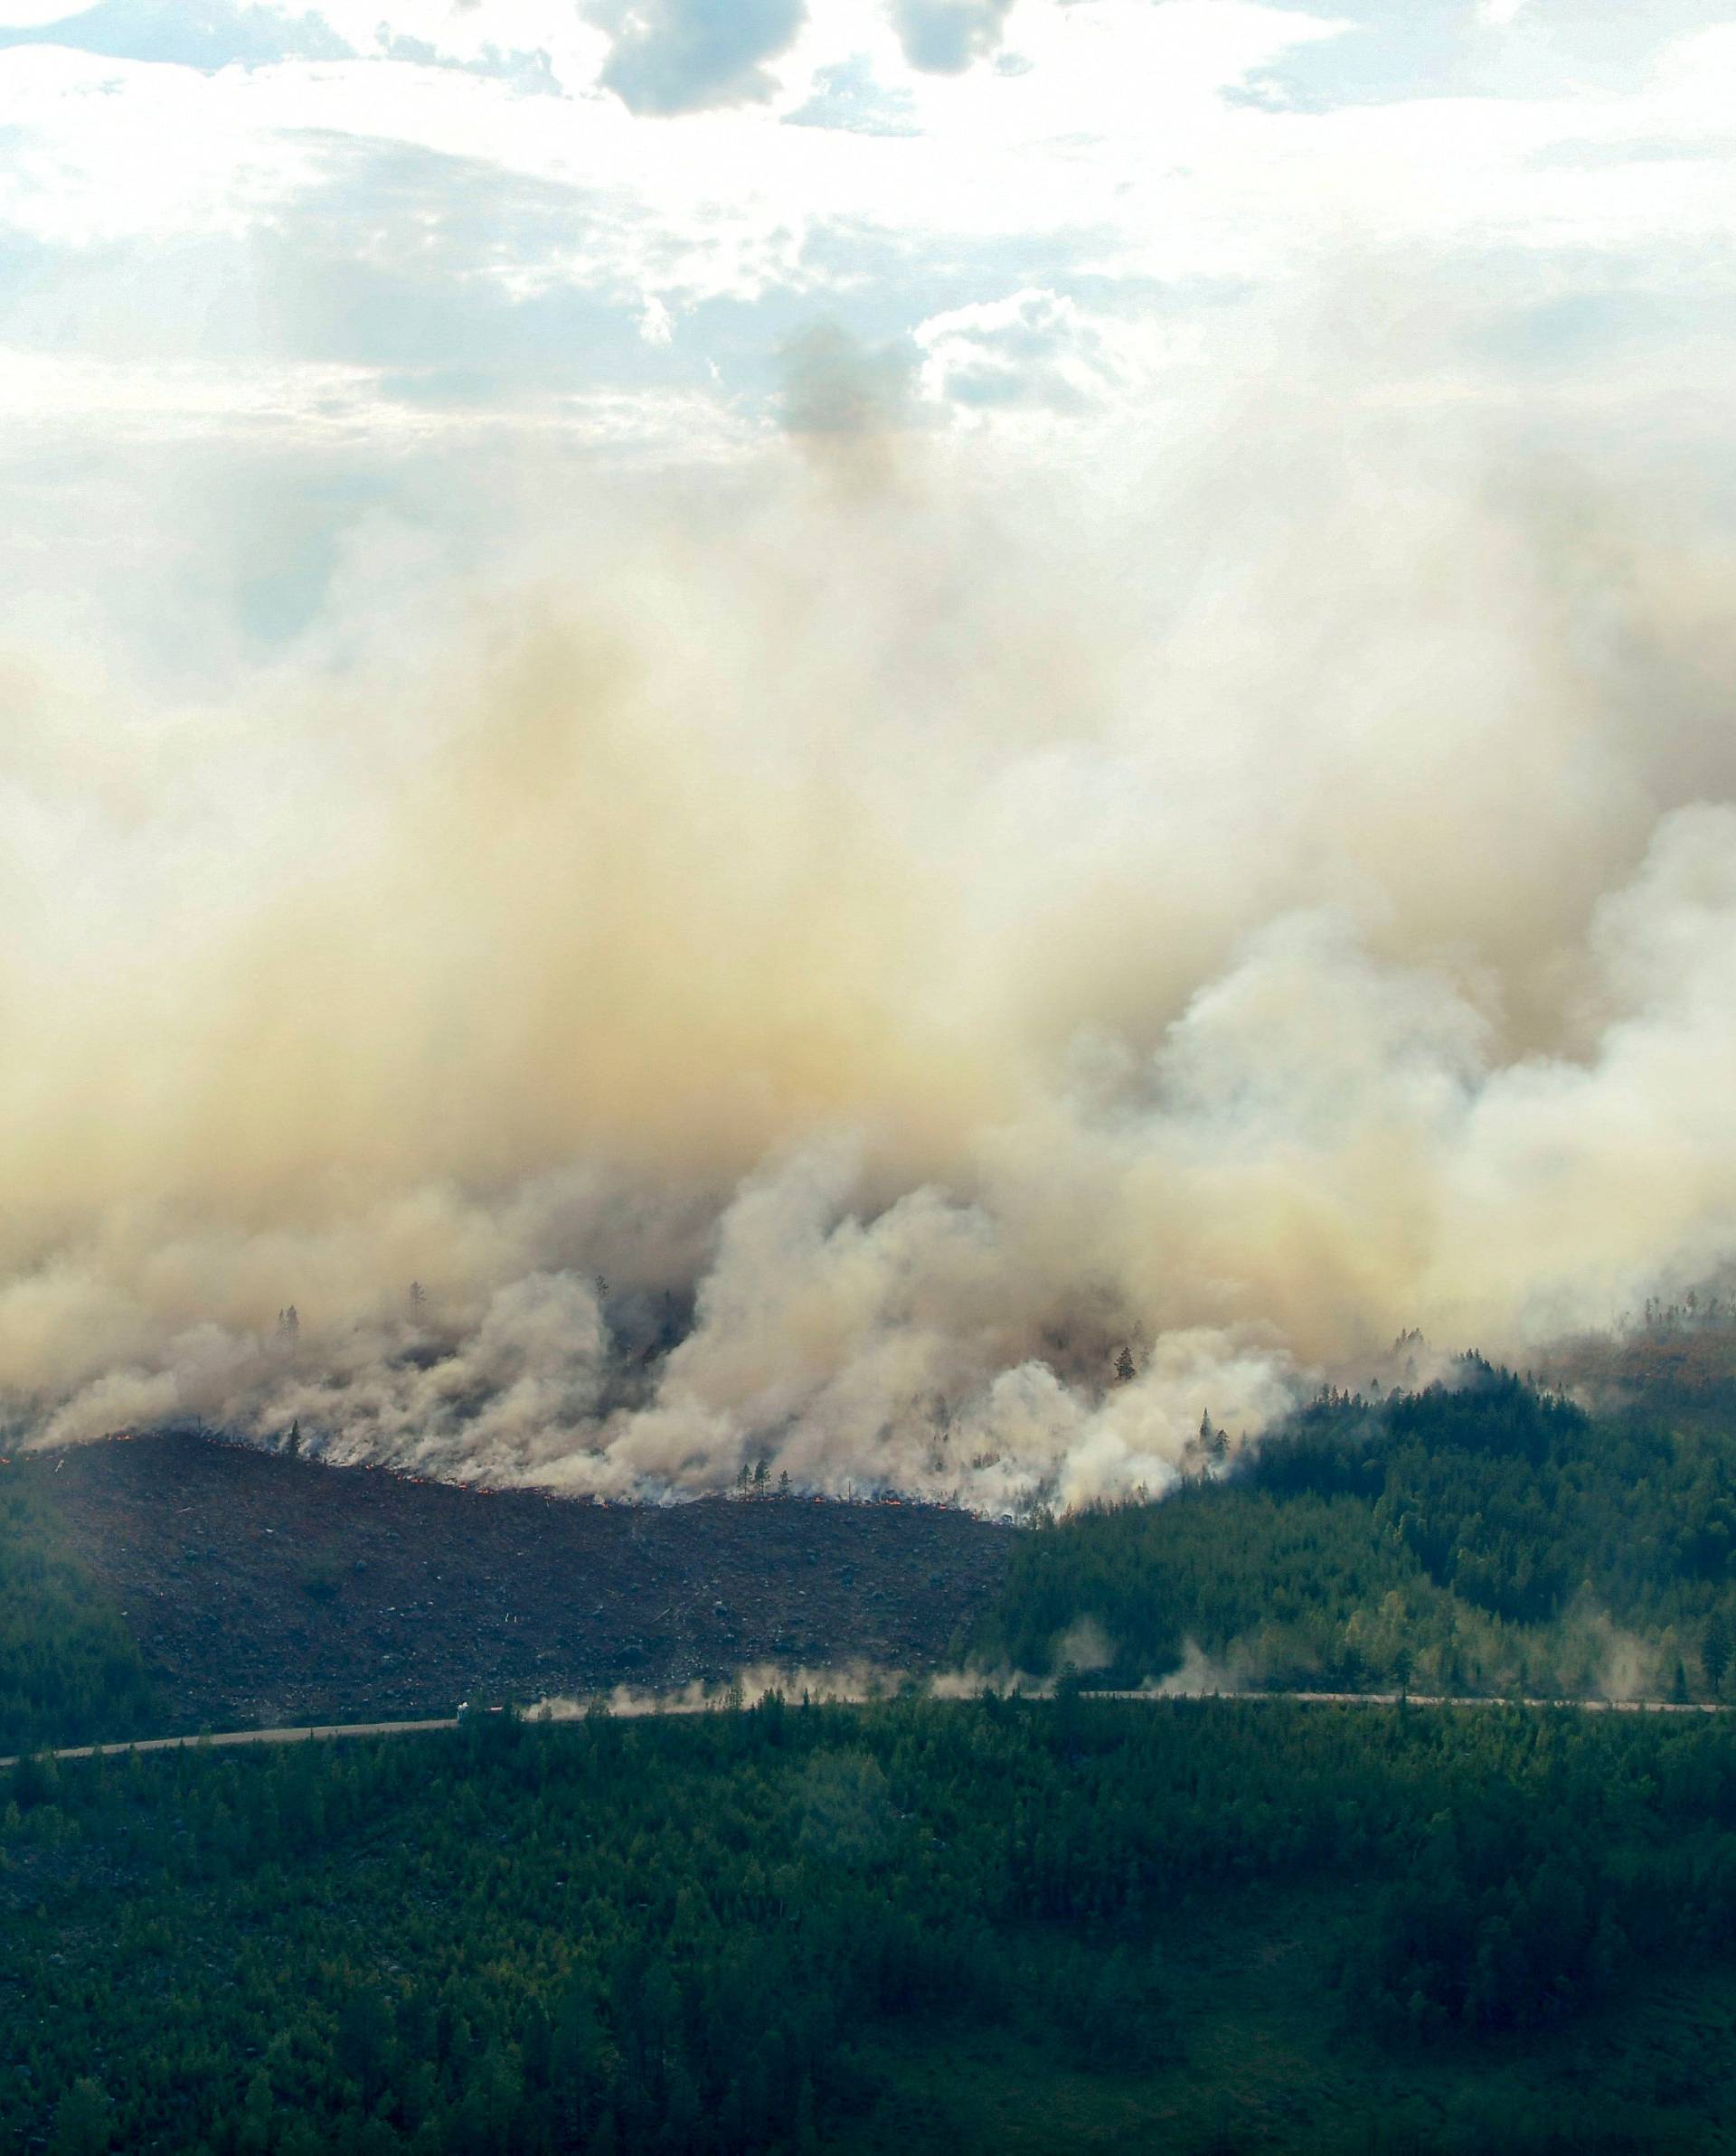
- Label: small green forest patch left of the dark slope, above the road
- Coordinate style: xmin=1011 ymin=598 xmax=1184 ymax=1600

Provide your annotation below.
xmin=0 ymin=1462 xmax=151 ymax=1755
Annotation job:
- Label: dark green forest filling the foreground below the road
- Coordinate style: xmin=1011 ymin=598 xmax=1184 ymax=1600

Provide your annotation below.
xmin=0 ymin=1692 xmax=1736 ymax=2156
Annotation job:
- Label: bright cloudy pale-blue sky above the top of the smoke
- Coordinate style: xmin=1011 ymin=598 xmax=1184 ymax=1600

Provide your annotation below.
xmin=0 ymin=0 xmax=1736 ymax=595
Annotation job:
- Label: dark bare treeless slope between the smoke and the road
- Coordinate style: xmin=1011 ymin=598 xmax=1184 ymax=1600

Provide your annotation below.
xmin=22 ymin=1436 xmax=1014 ymax=1729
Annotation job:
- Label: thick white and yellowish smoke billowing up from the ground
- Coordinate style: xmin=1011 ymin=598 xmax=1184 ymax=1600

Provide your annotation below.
xmin=0 ymin=340 xmax=1736 ymax=1507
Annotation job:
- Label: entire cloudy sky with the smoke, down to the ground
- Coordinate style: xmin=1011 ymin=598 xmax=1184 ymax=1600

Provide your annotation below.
xmin=0 ymin=0 xmax=1736 ymax=1510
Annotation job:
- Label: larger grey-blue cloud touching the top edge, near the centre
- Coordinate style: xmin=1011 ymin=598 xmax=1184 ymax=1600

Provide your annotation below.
xmin=589 ymin=0 xmax=807 ymax=117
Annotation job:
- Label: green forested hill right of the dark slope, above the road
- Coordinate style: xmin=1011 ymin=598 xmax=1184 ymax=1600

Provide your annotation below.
xmin=970 ymin=1360 xmax=1736 ymax=1699
